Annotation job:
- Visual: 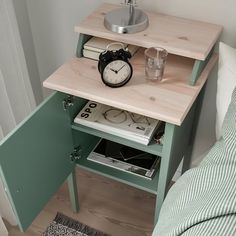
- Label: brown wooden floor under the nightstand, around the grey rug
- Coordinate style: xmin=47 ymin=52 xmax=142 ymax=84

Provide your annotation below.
xmin=8 ymin=168 xmax=155 ymax=236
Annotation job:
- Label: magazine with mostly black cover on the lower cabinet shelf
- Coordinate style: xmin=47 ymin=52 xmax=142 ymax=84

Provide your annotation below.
xmin=87 ymin=139 xmax=160 ymax=179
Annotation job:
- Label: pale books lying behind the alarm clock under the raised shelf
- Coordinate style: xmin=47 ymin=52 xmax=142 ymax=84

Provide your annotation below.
xmin=83 ymin=37 xmax=139 ymax=60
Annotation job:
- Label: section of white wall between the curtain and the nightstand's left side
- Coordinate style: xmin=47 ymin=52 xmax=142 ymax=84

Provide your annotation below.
xmin=26 ymin=0 xmax=101 ymax=97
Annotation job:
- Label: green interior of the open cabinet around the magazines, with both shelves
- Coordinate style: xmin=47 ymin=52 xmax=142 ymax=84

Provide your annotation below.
xmin=69 ymin=97 xmax=162 ymax=194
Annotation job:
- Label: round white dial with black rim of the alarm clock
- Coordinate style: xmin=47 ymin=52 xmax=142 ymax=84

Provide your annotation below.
xmin=102 ymin=60 xmax=133 ymax=87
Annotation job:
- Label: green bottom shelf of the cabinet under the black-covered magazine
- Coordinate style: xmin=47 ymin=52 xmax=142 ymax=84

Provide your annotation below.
xmin=77 ymin=152 xmax=159 ymax=194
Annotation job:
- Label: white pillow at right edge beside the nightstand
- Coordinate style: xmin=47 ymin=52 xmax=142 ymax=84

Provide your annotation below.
xmin=216 ymin=42 xmax=236 ymax=139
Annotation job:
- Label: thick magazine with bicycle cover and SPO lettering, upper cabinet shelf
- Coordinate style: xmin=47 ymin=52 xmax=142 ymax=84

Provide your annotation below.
xmin=74 ymin=101 xmax=161 ymax=145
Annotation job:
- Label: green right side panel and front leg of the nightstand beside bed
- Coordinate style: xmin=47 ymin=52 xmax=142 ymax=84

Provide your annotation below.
xmin=154 ymin=90 xmax=204 ymax=223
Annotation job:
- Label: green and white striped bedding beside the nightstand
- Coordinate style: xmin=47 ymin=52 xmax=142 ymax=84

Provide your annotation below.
xmin=153 ymin=88 xmax=236 ymax=236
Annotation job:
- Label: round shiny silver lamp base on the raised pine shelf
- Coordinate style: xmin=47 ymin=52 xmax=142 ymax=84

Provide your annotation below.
xmin=104 ymin=7 xmax=149 ymax=34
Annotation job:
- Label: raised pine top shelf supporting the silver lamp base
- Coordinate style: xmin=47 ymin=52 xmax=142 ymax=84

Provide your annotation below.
xmin=75 ymin=3 xmax=223 ymax=60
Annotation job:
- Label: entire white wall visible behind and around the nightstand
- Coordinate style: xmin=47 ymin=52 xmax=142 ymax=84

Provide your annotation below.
xmin=26 ymin=0 xmax=236 ymax=162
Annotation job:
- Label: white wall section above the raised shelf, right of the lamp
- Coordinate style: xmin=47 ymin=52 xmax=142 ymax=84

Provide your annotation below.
xmin=142 ymin=0 xmax=236 ymax=46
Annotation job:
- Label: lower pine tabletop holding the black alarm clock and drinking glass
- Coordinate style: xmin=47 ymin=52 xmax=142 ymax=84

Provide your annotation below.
xmin=43 ymin=49 xmax=217 ymax=125
